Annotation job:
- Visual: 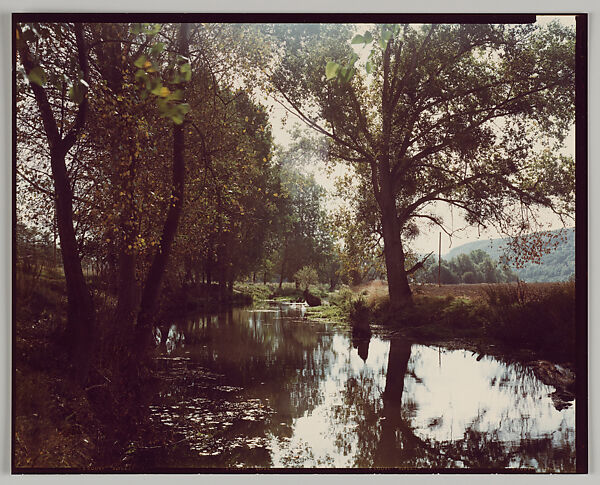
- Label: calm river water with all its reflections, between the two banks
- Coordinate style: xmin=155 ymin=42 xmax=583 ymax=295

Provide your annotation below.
xmin=146 ymin=304 xmax=575 ymax=471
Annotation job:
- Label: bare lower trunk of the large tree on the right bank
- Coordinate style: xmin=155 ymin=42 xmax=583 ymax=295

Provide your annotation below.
xmin=380 ymin=179 xmax=413 ymax=311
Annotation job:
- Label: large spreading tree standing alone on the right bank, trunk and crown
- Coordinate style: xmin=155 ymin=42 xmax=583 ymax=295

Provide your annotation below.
xmin=271 ymin=23 xmax=575 ymax=309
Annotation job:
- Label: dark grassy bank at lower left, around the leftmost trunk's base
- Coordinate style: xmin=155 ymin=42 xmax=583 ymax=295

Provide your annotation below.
xmin=12 ymin=271 xmax=188 ymax=471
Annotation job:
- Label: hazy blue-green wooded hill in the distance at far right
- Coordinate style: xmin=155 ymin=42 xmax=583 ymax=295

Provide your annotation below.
xmin=442 ymin=227 xmax=575 ymax=282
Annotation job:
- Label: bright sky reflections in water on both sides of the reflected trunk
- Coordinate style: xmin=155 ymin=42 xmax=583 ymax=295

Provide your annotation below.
xmin=271 ymin=335 xmax=575 ymax=467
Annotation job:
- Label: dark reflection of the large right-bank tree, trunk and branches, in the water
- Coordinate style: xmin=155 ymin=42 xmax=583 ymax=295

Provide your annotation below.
xmin=332 ymin=339 xmax=575 ymax=471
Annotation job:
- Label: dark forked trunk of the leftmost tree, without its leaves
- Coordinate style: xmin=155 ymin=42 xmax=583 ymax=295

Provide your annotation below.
xmin=17 ymin=23 xmax=95 ymax=381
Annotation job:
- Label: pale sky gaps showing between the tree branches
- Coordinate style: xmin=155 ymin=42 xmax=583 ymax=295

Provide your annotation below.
xmin=266 ymin=15 xmax=575 ymax=254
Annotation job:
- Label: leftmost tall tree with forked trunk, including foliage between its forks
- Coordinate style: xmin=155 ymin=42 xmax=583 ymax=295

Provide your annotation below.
xmin=15 ymin=23 xmax=95 ymax=379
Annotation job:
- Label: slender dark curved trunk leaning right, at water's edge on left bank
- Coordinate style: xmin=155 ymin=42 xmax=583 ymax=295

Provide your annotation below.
xmin=135 ymin=24 xmax=189 ymax=352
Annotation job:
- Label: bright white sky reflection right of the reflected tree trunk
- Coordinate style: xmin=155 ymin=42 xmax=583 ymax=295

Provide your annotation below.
xmin=404 ymin=346 xmax=575 ymax=441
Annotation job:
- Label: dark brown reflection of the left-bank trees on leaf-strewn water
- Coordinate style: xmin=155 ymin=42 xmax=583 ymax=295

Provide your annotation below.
xmin=148 ymin=302 xmax=334 ymax=467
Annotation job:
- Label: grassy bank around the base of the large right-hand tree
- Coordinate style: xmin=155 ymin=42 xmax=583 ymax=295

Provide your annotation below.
xmin=350 ymin=282 xmax=577 ymax=362
